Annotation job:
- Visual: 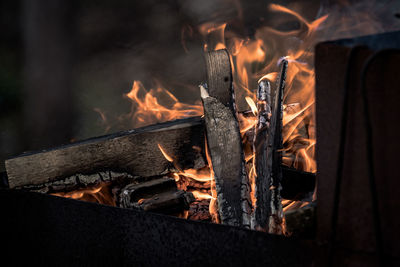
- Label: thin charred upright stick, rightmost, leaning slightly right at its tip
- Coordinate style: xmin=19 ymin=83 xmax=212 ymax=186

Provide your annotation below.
xmin=266 ymin=60 xmax=288 ymax=234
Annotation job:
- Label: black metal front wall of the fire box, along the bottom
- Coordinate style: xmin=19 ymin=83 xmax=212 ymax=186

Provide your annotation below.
xmin=0 ymin=190 xmax=313 ymax=266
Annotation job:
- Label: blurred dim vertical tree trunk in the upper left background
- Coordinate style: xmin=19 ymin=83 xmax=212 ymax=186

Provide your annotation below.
xmin=22 ymin=0 xmax=76 ymax=150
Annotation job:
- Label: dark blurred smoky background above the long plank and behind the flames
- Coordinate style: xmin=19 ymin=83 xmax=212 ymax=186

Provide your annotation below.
xmin=0 ymin=0 xmax=400 ymax=171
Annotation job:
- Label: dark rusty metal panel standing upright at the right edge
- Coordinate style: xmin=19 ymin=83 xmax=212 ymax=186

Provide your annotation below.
xmin=316 ymin=32 xmax=400 ymax=266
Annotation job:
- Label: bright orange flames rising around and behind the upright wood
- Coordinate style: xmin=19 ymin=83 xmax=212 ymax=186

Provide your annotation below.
xmin=83 ymin=4 xmax=398 ymax=226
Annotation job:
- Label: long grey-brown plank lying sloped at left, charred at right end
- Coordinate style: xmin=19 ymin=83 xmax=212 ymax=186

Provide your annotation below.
xmin=5 ymin=117 xmax=204 ymax=188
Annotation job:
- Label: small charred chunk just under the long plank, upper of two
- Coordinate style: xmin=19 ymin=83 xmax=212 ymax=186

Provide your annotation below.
xmin=119 ymin=177 xmax=178 ymax=208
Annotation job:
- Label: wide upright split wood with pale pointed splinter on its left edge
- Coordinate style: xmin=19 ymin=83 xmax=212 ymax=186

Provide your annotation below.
xmin=200 ymin=50 xmax=250 ymax=226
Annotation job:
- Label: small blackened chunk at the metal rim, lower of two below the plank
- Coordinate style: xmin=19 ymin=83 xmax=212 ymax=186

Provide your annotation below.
xmin=135 ymin=190 xmax=195 ymax=214
